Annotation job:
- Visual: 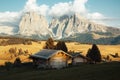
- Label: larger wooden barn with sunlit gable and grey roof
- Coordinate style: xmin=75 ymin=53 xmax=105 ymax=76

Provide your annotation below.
xmin=30 ymin=49 xmax=72 ymax=69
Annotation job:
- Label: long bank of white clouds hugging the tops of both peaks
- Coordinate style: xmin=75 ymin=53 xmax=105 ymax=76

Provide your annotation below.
xmin=0 ymin=0 xmax=103 ymax=24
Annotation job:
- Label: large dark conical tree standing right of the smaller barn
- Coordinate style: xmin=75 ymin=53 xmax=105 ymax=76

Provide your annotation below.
xmin=86 ymin=44 xmax=101 ymax=63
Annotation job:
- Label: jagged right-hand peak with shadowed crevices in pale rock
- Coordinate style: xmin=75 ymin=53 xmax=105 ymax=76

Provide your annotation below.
xmin=50 ymin=14 xmax=107 ymax=38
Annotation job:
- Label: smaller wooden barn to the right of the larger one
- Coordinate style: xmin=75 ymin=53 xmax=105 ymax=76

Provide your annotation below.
xmin=71 ymin=52 xmax=88 ymax=65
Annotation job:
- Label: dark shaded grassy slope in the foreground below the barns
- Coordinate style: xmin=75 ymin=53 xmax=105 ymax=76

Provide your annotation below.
xmin=0 ymin=62 xmax=120 ymax=80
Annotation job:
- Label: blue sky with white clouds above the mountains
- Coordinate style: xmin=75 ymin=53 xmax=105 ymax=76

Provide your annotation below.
xmin=0 ymin=0 xmax=120 ymax=32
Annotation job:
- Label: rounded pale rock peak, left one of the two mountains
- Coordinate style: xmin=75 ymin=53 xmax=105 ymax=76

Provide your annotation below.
xmin=19 ymin=12 xmax=50 ymax=36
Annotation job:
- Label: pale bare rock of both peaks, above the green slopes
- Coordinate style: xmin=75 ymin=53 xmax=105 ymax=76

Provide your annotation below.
xmin=19 ymin=12 xmax=120 ymax=39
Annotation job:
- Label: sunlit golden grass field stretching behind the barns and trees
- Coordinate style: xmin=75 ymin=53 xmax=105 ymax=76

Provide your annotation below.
xmin=0 ymin=41 xmax=120 ymax=65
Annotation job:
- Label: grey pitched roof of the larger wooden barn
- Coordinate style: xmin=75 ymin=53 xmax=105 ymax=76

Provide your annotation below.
xmin=31 ymin=49 xmax=72 ymax=59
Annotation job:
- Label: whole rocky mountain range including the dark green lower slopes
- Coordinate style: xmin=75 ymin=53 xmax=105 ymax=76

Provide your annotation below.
xmin=1 ymin=12 xmax=120 ymax=44
